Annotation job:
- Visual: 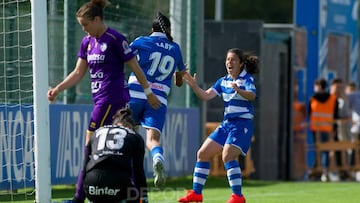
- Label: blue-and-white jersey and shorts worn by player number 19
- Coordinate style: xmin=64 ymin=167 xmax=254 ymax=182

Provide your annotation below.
xmin=128 ymin=32 xmax=185 ymax=132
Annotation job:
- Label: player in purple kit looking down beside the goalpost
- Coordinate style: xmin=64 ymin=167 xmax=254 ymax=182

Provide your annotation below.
xmin=47 ymin=0 xmax=161 ymax=202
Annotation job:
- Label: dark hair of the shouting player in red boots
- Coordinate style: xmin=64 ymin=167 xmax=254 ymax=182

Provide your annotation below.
xmin=227 ymin=48 xmax=259 ymax=74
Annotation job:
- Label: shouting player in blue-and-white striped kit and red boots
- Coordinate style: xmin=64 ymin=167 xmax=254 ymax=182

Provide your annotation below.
xmin=178 ymin=48 xmax=259 ymax=203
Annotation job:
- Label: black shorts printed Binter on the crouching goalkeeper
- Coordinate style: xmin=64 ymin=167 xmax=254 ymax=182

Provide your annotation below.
xmin=83 ymin=169 xmax=140 ymax=203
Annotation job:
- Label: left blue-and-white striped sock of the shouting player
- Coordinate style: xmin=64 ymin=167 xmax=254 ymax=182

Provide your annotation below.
xmin=193 ymin=161 xmax=210 ymax=194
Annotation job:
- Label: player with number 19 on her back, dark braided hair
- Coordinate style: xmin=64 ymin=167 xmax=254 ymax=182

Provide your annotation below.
xmin=128 ymin=12 xmax=185 ymax=187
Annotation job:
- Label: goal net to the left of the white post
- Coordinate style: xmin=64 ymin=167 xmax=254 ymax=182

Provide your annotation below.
xmin=0 ymin=0 xmax=35 ymax=201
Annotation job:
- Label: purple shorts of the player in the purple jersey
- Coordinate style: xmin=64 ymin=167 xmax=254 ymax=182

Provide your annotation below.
xmin=88 ymin=102 xmax=128 ymax=132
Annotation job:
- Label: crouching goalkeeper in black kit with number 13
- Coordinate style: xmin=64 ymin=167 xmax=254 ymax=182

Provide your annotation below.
xmin=83 ymin=108 xmax=148 ymax=203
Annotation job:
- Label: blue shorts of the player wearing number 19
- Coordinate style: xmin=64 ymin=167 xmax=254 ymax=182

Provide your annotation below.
xmin=129 ymin=98 xmax=167 ymax=133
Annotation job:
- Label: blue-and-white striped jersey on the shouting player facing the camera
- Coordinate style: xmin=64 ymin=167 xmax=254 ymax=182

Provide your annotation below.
xmin=211 ymin=70 xmax=256 ymax=120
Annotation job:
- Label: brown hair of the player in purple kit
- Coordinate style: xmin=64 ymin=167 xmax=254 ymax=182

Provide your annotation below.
xmin=76 ymin=0 xmax=110 ymax=20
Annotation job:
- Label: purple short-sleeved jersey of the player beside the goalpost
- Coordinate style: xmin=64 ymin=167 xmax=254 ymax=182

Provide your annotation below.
xmin=78 ymin=28 xmax=135 ymax=104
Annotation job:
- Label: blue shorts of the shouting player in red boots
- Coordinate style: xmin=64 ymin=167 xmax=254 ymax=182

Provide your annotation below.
xmin=209 ymin=118 xmax=254 ymax=156
